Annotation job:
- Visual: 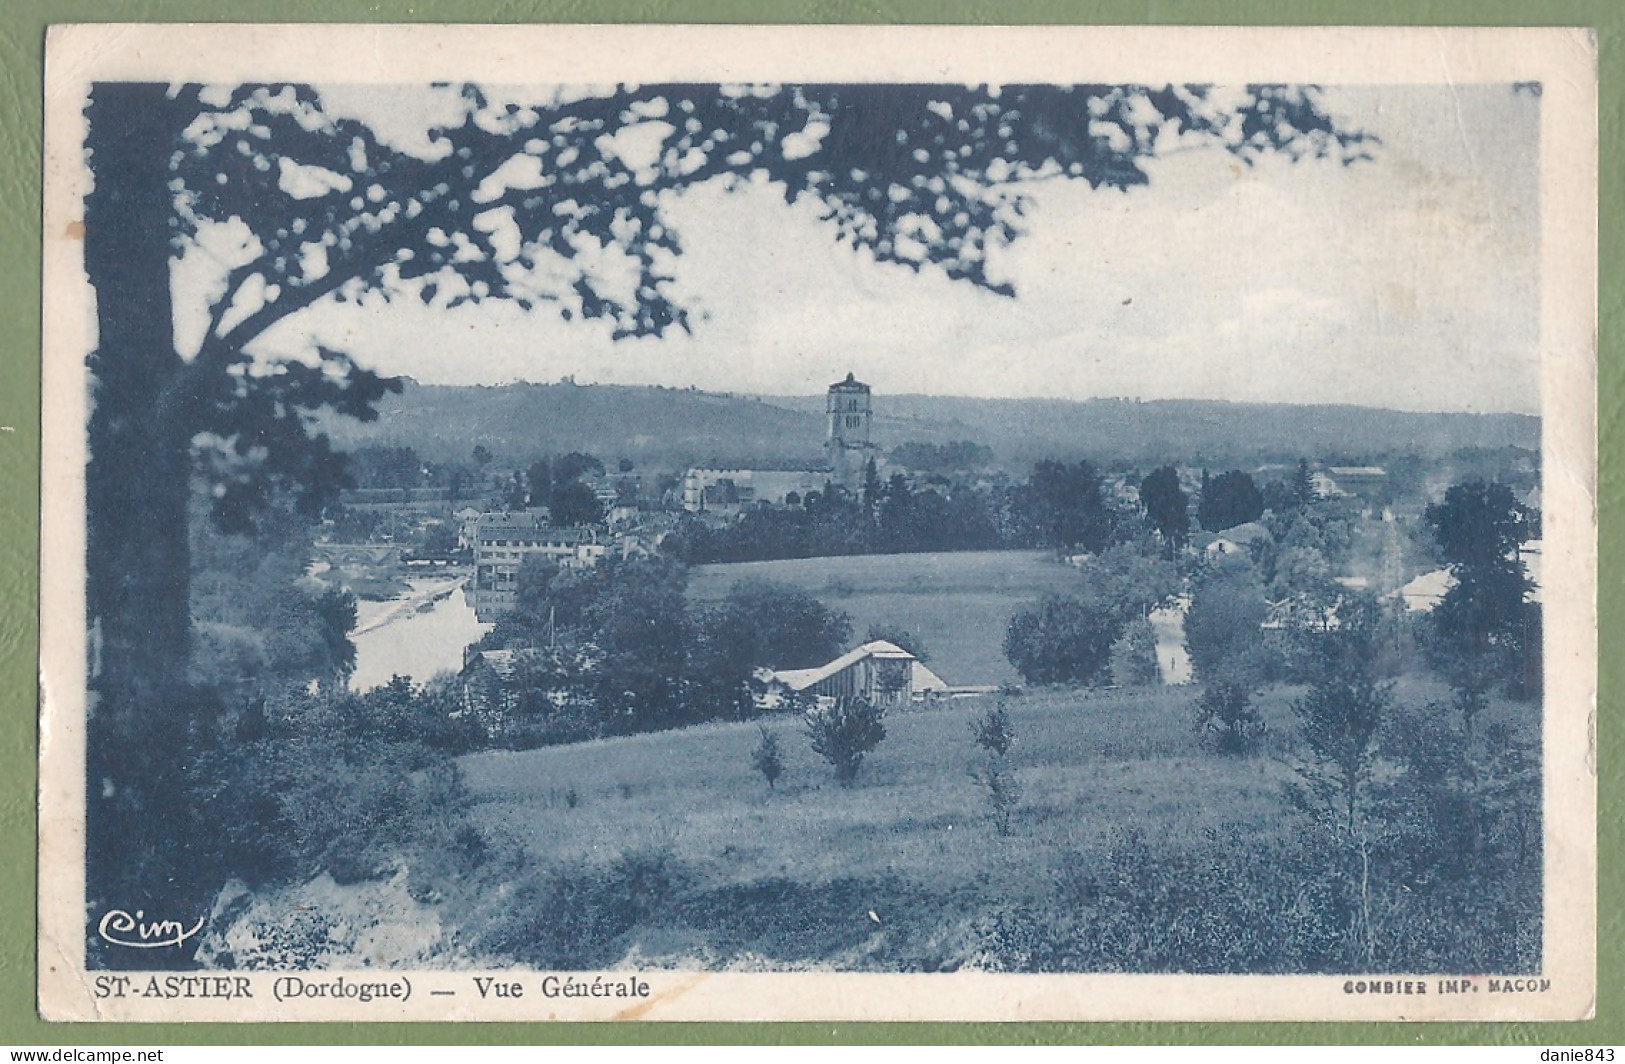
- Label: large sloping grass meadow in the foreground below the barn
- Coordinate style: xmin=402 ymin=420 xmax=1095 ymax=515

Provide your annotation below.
xmin=462 ymin=689 xmax=1539 ymax=971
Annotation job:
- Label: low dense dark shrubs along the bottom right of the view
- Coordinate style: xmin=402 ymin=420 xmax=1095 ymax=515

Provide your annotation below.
xmin=973 ymin=820 xmax=1541 ymax=975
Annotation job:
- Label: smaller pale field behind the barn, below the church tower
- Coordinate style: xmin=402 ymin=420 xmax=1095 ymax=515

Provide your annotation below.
xmin=689 ymin=551 xmax=1079 ymax=686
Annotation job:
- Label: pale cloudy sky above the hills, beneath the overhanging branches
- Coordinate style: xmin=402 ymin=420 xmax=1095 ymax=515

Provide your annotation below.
xmin=225 ymin=86 xmax=1539 ymax=413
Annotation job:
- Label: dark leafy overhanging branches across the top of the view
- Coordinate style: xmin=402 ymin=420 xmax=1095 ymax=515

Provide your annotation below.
xmin=171 ymin=84 xmax=1363 ymax=355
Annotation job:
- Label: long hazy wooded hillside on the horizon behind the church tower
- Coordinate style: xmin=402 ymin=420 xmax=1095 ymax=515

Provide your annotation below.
xmin=322 ymin=383 xmax=1541 ymax=466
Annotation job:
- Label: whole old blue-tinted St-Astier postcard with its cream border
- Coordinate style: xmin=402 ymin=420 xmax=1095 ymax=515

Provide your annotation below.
xmin=39 ymin=24 xmax=1597 ymax=1022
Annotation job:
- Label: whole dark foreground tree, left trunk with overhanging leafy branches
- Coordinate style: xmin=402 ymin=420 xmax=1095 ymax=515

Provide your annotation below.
xmin=85 ymin=83 xmax=1365 ymax=942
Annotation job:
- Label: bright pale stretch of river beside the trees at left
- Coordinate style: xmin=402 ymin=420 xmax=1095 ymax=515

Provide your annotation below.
xmin=349 ymin=577 xmax=491 ymax=690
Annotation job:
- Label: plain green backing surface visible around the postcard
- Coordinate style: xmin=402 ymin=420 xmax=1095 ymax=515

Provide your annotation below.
xmin=0 ymin=0 xmax=1625 ymax=1059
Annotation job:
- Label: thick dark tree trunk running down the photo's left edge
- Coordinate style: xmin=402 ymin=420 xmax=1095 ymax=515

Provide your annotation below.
xmin=85 ymin=83 xmax=197 ymax=963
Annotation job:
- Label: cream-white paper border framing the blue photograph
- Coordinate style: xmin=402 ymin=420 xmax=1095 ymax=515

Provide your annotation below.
xmin=39 ymin=24 xmax=1597 ymax=1020
